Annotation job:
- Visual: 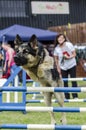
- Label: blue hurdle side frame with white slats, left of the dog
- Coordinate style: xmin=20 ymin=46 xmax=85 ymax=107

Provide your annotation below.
xmin=0 ymin=67 xmax=26 ymax=107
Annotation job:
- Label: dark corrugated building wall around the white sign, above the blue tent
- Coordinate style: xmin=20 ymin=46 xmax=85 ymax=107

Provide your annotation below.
xmin=0 ymin=0 xmax=86 ymax=29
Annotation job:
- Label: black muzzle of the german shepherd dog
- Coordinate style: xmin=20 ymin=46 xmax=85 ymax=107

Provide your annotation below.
xmin=14 ymin=55 xmax=27 ymax=66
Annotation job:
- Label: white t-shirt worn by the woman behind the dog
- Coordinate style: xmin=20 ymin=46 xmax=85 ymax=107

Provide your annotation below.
xmin=54 ymin=42 xmax=76 ymax=70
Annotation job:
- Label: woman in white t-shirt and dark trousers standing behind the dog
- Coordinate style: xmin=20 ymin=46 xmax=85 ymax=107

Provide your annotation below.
xmin=54 ymin=34 xmax=78 ymax=99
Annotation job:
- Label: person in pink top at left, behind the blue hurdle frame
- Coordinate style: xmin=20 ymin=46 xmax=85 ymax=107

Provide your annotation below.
xmin=2 ymin=42 xmax=18 ymax=86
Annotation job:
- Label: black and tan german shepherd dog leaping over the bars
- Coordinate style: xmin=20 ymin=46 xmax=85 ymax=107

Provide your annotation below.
xmin=14 ymin=35 xmax=66 ymax=124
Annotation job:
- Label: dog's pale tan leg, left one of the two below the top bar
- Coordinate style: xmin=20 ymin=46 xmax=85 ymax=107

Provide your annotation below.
xmin=43 ymin=92 xmax=56 ymax=124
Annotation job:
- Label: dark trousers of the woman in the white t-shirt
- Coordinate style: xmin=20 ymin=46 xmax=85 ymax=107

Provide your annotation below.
xmin=61 ymin=66 xmax=78 ymax=99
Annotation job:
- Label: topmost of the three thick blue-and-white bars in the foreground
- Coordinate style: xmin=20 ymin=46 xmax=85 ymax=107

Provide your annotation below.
xmin=0 ymin=87 xmax=86 ymax=92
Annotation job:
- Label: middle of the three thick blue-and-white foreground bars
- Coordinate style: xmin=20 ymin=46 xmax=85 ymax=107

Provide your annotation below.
xmin=0 ymin=106 xmax=86 ymax=112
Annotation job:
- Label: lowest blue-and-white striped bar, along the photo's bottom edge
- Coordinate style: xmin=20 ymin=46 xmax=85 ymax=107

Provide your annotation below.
xmin=0 ymin=124 xmax=86 ymax=130
